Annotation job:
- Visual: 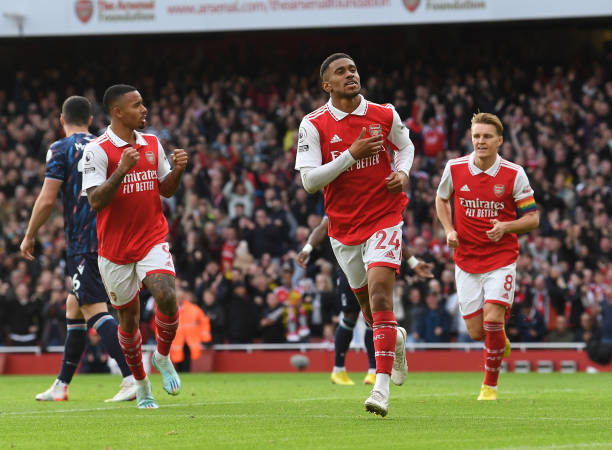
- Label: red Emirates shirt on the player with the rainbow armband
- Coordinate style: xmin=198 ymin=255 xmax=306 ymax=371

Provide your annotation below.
xmin=438 ymin=153 xmax=535 ymax=273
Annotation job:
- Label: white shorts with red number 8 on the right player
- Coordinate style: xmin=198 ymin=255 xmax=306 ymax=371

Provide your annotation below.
xmin=455 ymin=263 xmax=516 ymax=319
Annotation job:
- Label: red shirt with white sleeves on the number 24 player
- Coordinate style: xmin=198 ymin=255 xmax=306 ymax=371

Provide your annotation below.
xmin=296 ymin=98 xmax=410 ymax=245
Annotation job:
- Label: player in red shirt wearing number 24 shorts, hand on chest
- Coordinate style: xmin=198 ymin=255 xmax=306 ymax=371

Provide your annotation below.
xmin=295 ymin=53 xmax=414 ymax=416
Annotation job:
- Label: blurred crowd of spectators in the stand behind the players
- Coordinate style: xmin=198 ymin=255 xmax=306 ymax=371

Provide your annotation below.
xmin=0 ymin=36 xmax=612 ymax=347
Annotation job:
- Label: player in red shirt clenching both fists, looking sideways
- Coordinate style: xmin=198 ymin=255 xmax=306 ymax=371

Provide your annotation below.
xmin=83 ymin=85 xmax=188 ymax=408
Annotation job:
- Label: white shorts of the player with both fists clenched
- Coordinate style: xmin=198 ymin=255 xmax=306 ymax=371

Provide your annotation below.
xmin=98 ymin=242 xmax=176 ymax=309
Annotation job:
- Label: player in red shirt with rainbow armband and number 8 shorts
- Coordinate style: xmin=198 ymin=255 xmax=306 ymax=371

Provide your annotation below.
xmin=436 ymin=113 xmax=540 ymax=400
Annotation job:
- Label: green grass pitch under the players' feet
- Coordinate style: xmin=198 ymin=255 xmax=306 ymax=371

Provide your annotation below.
xmin=0 ymin=373 xmax=612 ymax=450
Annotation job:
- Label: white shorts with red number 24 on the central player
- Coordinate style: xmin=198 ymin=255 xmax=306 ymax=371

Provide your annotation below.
xmin=329 ymin=222 xmax=404 ymax=291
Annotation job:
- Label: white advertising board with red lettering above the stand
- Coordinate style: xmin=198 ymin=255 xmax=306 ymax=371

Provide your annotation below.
xmin=0 ymin=0 xmax=612 ymax=37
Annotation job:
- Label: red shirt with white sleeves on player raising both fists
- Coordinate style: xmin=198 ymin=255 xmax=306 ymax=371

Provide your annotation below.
xmin=83 ymin=127 xmax=170 ymax=264
